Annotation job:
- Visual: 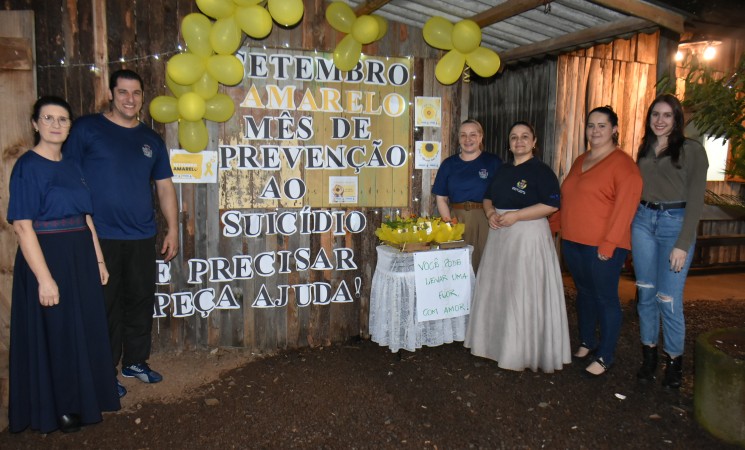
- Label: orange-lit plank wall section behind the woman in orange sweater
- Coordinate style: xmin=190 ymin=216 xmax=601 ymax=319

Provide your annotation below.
xmin=552 ymin=33 xmax=659 ymax=180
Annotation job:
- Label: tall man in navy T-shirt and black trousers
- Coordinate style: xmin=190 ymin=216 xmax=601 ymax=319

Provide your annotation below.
xmin=63 ymin=70 xmax=178 ymax=397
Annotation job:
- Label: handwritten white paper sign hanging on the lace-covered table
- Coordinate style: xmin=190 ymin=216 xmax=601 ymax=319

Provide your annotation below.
xmin=414 ymin=248 xmax=471 ymax=322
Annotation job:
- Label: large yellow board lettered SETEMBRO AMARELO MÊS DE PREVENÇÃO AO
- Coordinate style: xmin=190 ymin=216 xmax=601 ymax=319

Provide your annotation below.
xmin=218 ymin=47 xmax=413 ymax=209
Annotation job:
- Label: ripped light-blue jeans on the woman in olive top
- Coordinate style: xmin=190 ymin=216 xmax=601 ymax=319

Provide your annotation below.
xmin=631 ymin=205 xmax=696 ymax=358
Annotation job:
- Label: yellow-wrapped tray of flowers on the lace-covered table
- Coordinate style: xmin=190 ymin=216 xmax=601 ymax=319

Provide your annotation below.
xmin=375 ymin=215 xmax=466 ymax=247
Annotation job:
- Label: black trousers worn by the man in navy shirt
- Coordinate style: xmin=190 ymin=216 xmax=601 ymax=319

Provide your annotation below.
xmin=101 ymin=237 xmax=156 ymax=372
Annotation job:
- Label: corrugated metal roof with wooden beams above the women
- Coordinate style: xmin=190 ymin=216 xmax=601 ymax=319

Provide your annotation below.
xmin=346 ymin=0 xmax=684 ymax=62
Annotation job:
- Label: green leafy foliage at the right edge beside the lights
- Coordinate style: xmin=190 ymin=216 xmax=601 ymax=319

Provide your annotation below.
xmin=658 ymin=54 xmax=745 ymax=178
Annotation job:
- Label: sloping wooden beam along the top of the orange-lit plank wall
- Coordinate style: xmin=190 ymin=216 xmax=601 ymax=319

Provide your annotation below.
xmin=499 ymin=17 xmax=657 ymax=64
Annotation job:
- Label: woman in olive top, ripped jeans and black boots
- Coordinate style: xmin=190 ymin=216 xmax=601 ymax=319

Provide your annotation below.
xmin=631 ymin=94 xmax=709 ymax=388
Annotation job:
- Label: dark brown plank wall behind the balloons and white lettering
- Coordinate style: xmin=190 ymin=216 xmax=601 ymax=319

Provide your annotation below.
xmin=0 ymin=0 xmax=454 ymax=352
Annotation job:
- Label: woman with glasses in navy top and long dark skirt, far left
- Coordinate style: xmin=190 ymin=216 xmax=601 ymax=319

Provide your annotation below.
xmin=8 ymin=97 xmax=120 ymax=433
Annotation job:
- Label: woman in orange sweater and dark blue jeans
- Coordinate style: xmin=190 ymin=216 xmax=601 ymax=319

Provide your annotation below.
xmin=561 ymin=106 xmax=642 ymax=376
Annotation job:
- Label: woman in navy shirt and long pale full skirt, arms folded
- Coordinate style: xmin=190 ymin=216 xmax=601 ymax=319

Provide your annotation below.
xmin=465 ymin=122 xmax=571 ymax=373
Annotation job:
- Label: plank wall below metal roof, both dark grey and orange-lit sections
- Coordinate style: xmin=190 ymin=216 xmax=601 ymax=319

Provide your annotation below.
xmin=469 ymin=33 xmax=658 ymax=180
